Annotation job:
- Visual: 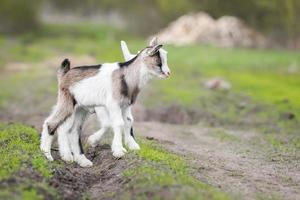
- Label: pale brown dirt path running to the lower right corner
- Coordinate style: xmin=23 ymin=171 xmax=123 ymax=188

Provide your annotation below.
xmin=136 ymin=122 xmax=300 ymax=199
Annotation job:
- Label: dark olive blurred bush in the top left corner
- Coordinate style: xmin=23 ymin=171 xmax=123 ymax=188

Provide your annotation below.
xmin=0 ymin=0 xmax=42 ymax=33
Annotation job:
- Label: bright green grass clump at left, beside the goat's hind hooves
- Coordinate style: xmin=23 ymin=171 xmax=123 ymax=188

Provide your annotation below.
xmin=0 ymin=124 xmax=50 ymax=179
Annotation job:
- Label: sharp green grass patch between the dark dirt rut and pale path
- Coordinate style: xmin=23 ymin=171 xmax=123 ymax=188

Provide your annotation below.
xmin=124 ymin=140 xmax=231 ymax=200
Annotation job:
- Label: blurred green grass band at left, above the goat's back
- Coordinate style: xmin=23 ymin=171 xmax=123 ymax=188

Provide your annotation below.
xmin=0 ymin=24 xmax=141 ymax=64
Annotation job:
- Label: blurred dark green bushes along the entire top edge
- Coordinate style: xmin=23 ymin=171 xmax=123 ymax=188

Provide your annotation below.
xmin=0 ymin=0 xmax=300 ymax=45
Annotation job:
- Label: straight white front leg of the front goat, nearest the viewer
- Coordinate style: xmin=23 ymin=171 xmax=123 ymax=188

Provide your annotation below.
xmin=108 ymin=104 xmax=127 ymax=158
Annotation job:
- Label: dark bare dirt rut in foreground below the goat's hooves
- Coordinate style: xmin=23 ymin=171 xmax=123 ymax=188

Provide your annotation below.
xmin=50 ymin=144 xmax=128 ymax=200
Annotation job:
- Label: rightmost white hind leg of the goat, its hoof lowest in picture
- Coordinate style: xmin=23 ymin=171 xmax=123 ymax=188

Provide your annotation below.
xmin=68 ymin=108 xmax=93 ymax=167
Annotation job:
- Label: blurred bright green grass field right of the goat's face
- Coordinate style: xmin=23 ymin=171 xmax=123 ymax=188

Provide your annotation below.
xmin=149 ymin=46 xmax=300 ymax=109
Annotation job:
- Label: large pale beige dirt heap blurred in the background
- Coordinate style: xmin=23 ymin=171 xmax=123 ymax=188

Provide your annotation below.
xmin=157 ymin=12 xmax=270 ymax=48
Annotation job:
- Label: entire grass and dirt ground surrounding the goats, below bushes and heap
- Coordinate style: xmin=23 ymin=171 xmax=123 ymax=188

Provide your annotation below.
xmin=0 ymin=25 xmax=300 ymax=199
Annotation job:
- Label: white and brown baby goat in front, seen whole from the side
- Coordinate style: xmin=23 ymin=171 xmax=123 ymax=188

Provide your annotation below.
xmin=41 ymin=39 xmax=170 ymax=166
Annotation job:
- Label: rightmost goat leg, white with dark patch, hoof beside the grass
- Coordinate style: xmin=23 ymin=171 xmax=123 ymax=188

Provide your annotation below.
xmin=123 ymin=106 xmax=140 ymax=150
